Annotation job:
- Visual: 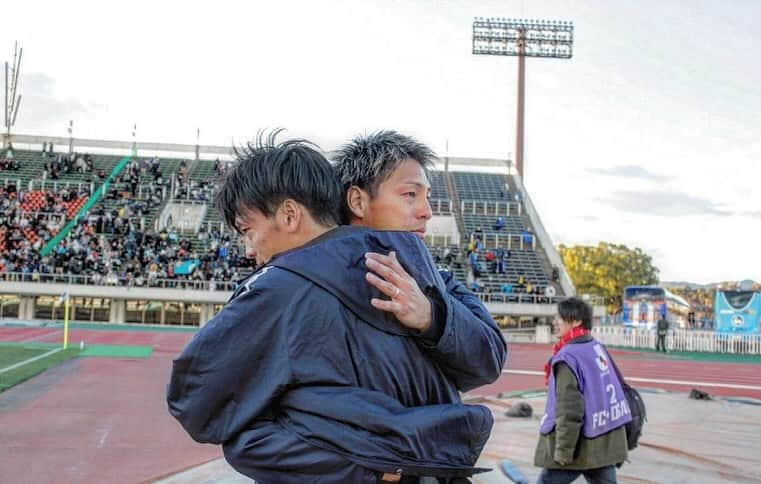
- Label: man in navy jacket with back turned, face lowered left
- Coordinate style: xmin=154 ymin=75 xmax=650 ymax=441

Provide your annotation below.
xmin=167 ymin=132 xmax=493 ymax=484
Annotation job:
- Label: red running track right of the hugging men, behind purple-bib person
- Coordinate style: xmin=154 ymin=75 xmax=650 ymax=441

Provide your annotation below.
xmin=471 ymin=344 xmax=761 ymax=399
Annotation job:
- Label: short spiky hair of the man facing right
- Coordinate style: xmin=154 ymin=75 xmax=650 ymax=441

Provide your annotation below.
xmin=332 ymin=130 xmax=436 ymax=223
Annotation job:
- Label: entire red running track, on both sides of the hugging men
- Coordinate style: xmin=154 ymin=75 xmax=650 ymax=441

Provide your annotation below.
xmin=0 ymin=327 xmax=761 ymax=483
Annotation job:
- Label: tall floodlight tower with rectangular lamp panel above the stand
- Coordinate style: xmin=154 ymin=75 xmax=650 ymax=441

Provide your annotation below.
xmin=473 ymin=18 xmax=573 ymax=182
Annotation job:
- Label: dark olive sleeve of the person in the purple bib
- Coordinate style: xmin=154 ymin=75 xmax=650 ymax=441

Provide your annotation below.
xmin=553 ymin=363 xmax=584 ymax=464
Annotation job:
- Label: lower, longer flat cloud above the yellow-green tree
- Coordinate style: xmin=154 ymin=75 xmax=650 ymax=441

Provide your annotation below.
xmin=601 ymin=190 xmax=731 ymax=217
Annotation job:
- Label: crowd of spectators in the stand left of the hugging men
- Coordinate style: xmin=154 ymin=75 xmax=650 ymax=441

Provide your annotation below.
xmin=0 ymin=144 xmax=253 ymax=289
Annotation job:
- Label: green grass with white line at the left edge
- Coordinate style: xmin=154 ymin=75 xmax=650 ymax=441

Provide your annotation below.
xmin=0 ymin=345 xmax=80 ymax=393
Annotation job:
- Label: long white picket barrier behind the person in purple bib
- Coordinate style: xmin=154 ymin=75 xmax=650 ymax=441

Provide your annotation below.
xmin=592 ymin=326 xmax=761 ymax=355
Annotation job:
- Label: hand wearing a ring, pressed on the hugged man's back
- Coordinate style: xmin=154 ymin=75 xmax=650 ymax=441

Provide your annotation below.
xmin=365 ymin=252 xmax=431 ymax=332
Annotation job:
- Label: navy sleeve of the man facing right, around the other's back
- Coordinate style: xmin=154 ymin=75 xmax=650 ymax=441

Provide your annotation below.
xmin=420 ymin=271 xmax=507 ymax=392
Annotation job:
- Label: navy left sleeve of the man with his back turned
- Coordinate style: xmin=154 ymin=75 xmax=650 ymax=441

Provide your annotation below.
xmin=167 ymin=287 xmax=294 ymax=444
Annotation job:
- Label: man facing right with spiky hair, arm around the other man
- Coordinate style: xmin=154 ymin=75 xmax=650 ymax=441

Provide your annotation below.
xmin=333 ymin=131 xmax=507 ymax=391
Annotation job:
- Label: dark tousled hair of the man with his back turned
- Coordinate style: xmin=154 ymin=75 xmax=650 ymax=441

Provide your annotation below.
xmin=214 ymin=129 xmax=341 ymax=233
